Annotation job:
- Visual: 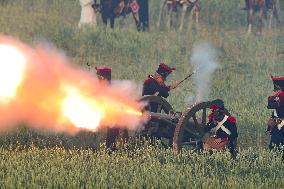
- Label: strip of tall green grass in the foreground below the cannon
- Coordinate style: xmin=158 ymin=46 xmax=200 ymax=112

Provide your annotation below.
xmin=0 ymin=144 xmax=284 ymax=188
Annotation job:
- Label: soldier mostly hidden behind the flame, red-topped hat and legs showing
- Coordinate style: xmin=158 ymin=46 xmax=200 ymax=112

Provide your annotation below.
xmin=96 ymin=67 xmax=119 ymax=151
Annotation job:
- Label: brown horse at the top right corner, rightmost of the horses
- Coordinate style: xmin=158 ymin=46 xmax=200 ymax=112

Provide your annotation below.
xmin=245 ymin=0 xmax=280 ymax=34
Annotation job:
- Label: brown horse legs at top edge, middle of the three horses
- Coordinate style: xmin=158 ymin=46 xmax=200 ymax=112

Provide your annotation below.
xmin=157 ymin=0 xmax=200 ymax=31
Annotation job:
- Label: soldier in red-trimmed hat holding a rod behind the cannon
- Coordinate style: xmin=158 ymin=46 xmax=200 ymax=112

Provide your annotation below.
xmin=142 ymin=63 xmax=177 ymax=112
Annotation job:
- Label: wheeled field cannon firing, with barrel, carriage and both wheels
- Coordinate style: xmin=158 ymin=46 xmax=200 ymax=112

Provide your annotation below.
xmin=136 ymin=96 xmax=230 ymax=151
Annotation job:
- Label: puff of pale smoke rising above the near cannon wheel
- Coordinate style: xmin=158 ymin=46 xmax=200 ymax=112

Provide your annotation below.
xmin=190 ymin=42 xmax=220 ymax=101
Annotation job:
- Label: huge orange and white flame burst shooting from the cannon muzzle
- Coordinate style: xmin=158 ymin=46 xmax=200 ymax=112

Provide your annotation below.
xmin=0 ymin=36 xmax=144 ymax=133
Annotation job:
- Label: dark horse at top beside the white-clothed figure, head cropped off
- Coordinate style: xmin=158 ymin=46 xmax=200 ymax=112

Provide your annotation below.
xmin=94 ymin=0 xmax=149 ymax=31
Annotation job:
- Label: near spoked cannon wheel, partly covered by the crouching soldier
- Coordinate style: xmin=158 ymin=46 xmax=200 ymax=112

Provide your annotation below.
xmin=173 ymin=101 xmax=230 ymax=152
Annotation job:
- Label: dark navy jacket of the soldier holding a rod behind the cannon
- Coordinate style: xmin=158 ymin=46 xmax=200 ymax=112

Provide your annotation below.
xmin=142 ymin=75 xmax=170 ymax=98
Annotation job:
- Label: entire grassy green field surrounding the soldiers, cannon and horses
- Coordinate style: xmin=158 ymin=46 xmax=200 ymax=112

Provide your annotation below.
xmin=0 ymin=0 xmax=284 ymax=188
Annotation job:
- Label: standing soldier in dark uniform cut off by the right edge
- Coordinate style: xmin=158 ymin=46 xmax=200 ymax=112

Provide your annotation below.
xmin=267 ymin=77 xmax=284 ymax=149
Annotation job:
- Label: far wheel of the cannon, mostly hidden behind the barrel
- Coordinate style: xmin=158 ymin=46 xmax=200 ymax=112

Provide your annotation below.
xmin=136 ymin=95 xmax=173 ymax=147
